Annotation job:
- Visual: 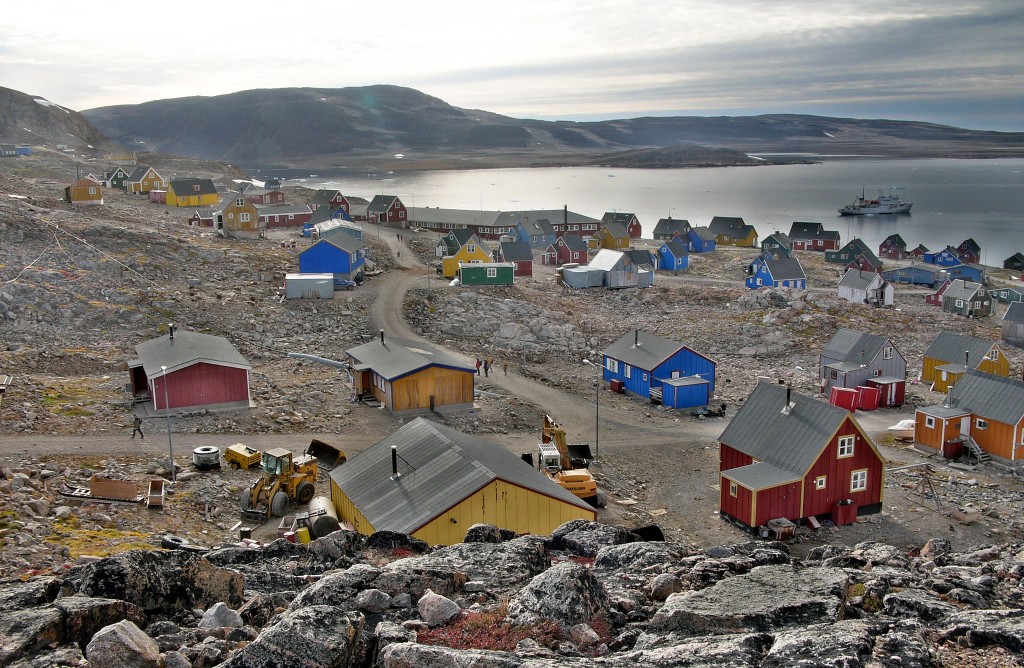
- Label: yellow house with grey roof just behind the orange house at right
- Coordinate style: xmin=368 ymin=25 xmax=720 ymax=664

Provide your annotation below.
xmin=921 ymin=332 xmax=1010 ymax=392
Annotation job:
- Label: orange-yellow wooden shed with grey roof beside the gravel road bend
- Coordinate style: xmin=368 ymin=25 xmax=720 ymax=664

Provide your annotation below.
xmin=345 ymin=330 xmax=476 ymax=415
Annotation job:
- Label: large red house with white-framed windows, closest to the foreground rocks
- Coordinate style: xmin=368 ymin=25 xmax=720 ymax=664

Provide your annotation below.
xmin=719 ymin=382 xmax=885 ymax=529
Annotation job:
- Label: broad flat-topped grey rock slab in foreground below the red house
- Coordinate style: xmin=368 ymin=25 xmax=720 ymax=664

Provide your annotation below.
xmin=650 ymin=566 xmax=848 ymax=635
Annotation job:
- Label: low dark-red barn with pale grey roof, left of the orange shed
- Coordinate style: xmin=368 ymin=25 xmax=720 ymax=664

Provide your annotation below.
xmin=128 ymin=325 xmax=252 ymax=412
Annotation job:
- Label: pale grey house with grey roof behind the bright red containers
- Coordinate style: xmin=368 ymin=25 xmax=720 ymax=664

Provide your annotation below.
xmin=818 ymin=328 xmax=906 ymax=392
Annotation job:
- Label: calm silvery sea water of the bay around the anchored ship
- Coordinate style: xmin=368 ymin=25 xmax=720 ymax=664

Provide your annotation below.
xmin=303 ymin=158 xmax=1024 ymax=266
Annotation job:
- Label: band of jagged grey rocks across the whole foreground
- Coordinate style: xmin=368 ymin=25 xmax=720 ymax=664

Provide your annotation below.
xmin=0 ymin=520 xmax=1024 ymax=668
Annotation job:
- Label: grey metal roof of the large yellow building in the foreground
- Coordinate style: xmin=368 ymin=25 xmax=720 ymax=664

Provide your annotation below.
xmin=331 ymin=418 xmax=592 ymax=534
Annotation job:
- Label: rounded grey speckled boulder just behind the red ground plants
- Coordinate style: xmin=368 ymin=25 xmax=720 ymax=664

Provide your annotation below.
xmin=508 ymin=561 xmax=608 ymax=626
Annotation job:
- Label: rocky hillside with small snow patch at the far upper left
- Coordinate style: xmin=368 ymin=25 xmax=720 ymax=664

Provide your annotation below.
xmin=0 ymin=87 xmax=111 ymax=149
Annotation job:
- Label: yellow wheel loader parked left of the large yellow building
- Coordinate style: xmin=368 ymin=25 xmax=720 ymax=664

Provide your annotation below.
xmin=241 ymin=448 xmax=319 ymax=521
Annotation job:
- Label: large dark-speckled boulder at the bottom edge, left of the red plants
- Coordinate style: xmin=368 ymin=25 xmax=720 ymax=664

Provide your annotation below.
xmin=220 ymin=606 xmax=365 ymax=668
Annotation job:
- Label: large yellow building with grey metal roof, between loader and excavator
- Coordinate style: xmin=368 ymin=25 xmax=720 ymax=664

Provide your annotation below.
xmin=331 ymin=418 xmax=597 ymax=545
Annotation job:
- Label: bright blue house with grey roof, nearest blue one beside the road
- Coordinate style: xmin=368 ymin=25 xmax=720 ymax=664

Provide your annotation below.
xmin=601 ymin=330 xmax=716 ymax=409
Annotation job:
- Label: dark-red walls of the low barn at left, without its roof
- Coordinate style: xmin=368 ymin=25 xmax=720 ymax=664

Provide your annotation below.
xmin=153 ymin=362 xmax=249 ymax=411
